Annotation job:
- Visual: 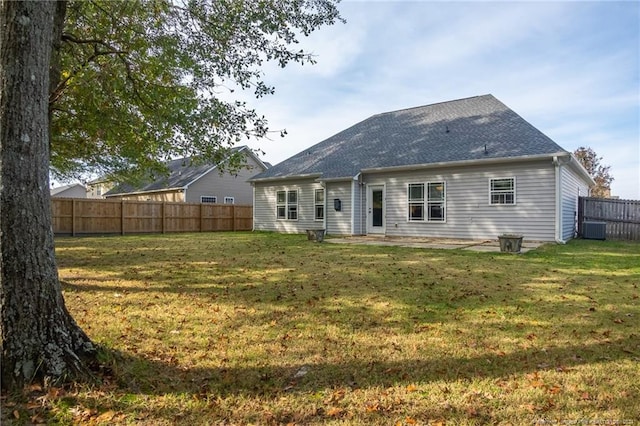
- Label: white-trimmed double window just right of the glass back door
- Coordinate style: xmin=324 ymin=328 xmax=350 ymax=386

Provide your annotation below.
xmin=407 ymin=182 xmax=446 ymax=222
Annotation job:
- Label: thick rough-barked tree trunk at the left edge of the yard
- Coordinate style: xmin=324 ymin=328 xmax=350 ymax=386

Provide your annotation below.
xmin=0 ymin=0 xmax=95 ymax=389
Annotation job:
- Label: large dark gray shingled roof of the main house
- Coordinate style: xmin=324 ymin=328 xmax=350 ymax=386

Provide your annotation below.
xmin=251 ymin=95 xmax=566 ymax=180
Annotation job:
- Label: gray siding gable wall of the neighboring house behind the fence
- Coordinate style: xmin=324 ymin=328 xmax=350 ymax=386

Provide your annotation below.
xmin=185 ymin=156 xmax=264 ymax=205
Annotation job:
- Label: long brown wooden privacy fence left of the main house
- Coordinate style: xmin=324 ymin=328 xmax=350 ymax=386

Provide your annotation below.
xmin=51 ymin=198 xmax=253 ymax=235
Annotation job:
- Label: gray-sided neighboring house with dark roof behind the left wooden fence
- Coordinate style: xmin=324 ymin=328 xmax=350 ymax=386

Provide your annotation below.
xmin=105 ymin=146 xmax=267 ymax=205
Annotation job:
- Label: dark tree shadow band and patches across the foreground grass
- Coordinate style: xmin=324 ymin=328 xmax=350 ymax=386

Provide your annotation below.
xmin=61 ymin=335 xmax=640 ymax=424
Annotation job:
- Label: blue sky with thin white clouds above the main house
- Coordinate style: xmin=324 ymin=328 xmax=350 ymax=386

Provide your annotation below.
xmin=241 ymin=1 xmax=640 ymax=199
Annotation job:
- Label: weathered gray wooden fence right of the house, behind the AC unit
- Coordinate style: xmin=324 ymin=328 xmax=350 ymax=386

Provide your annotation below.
xmin=578 ymin=197 xmax=640 ymax=240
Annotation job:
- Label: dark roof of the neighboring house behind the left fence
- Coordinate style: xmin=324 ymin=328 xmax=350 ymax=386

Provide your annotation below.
xmin=105 ymin=146 xmax=266 ymax=196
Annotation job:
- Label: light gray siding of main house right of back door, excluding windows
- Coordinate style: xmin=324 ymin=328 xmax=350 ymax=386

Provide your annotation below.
xmin=363 ymin=161 xmax=555 ymax=241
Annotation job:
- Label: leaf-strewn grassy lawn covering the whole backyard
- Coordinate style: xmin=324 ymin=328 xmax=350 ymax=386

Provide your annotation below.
xmin=2 ymin=233 xmax=640 ymax=425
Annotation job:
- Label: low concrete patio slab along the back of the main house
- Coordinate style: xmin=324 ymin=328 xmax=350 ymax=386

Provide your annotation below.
xmin=324 ymin=235 xmax=545 ymax=253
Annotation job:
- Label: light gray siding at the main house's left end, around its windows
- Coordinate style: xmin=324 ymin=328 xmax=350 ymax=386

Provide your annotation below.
xmin=253 ymin=179 xmax=324 ymax=234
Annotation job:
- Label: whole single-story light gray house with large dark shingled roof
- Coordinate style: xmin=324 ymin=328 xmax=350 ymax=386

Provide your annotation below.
xmin=250 ymin=95 xmax=594 ymax=242
